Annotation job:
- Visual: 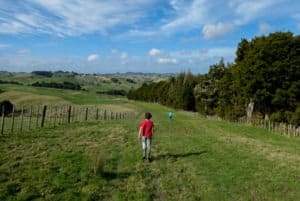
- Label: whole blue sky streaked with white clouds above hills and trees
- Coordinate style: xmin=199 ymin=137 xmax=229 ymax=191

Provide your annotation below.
xmin=0 ymin=0 xmax=300 ymax=74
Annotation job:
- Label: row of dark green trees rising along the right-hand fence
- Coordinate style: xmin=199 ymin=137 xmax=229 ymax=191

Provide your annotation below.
xmin=127 ymin=32 xmax=300 ymax=125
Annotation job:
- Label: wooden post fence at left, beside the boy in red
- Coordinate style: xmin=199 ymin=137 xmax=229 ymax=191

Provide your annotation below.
xmin=0 ymin=105 xmax=135 ymax=135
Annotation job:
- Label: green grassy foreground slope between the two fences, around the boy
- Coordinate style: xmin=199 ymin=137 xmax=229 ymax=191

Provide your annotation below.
xmin=0 ymin=101 xmax=300 ymax=201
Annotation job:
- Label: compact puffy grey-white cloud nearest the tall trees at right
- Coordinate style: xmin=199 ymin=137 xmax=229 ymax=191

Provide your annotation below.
xmin=202 ymin=23 xmax=234 ymax=39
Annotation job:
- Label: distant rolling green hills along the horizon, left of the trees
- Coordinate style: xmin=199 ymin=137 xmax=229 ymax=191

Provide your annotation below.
xmin=0 ymin=71 xmax=175 ymax=93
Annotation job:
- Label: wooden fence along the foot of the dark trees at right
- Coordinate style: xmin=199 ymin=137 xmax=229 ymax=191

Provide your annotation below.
xmin=206 ymin=116 xmax=300 ymax=137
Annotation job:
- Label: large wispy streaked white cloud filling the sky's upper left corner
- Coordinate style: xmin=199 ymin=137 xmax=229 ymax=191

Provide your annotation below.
xmin=0 ymin=0 xmax=152 ymax=36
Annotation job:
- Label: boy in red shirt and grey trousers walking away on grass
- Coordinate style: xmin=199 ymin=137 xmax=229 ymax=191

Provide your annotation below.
xmin=138 ymin=112 xmax=154 ymax=162
